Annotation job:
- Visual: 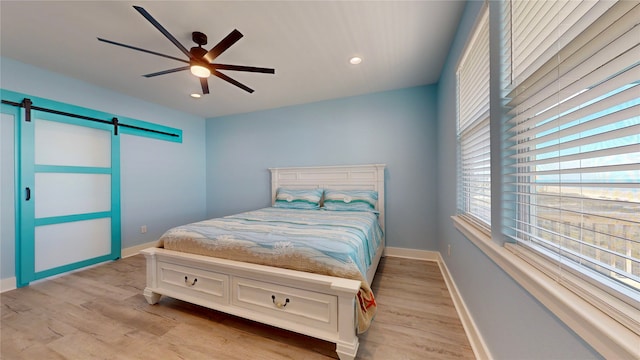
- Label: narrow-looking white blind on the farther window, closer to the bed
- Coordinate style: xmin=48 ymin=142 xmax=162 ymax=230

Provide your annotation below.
xmin=457 ymin=9 xmax=491 ymax=227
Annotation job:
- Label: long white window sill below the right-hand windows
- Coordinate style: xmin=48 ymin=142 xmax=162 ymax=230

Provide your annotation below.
xmin=452 ymin=216 xmax=640 ymax=359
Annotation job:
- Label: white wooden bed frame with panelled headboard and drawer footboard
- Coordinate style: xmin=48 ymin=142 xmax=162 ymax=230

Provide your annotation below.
xmin=141 ymin=164 xmax=385 ymax=360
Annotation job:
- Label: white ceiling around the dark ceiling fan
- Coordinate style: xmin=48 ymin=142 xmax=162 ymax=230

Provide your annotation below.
xmin=0 ymin=0 xmax=465 ymax=118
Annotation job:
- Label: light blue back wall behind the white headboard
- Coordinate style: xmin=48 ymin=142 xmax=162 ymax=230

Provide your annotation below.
xmin=207 ymin=86 xmax=437 ymax=250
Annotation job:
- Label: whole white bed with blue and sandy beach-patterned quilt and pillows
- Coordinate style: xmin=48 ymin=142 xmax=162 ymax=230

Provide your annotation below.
xmin=142 ymin=164 xmax=385 ymax=360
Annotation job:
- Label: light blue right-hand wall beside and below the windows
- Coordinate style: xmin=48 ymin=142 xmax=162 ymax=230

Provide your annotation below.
xmin=434 ymin=1 xmax=600 ymax=360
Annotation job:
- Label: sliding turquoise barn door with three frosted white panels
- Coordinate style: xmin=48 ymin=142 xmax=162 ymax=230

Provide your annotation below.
xmin=16 ymin=110 xmax=120 ymax=286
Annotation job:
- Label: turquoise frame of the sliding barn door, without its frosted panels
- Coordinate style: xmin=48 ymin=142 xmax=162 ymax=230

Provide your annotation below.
xmin=16 ymin=109 xmax=121 ymax=287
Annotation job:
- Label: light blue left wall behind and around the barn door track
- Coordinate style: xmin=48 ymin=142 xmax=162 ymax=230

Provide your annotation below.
xmin=0 ymin=58 xmax=206 ymax=278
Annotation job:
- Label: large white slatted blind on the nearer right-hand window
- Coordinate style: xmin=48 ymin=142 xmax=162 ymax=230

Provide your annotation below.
xmin=504 ymin=1 xmax=640 ymax=318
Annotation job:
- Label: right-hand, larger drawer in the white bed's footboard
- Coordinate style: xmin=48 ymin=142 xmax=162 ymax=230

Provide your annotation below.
xmin=231 ymin=277 xmax=338 ymax=331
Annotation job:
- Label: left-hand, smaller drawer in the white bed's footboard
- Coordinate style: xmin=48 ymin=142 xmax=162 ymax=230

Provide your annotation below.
xmin=158 ymin=262 xmax=229 ymax=304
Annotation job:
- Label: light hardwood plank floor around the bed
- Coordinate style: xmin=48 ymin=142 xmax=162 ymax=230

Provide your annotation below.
xmin=0 ymin=255 xmax=474 ymax=360
